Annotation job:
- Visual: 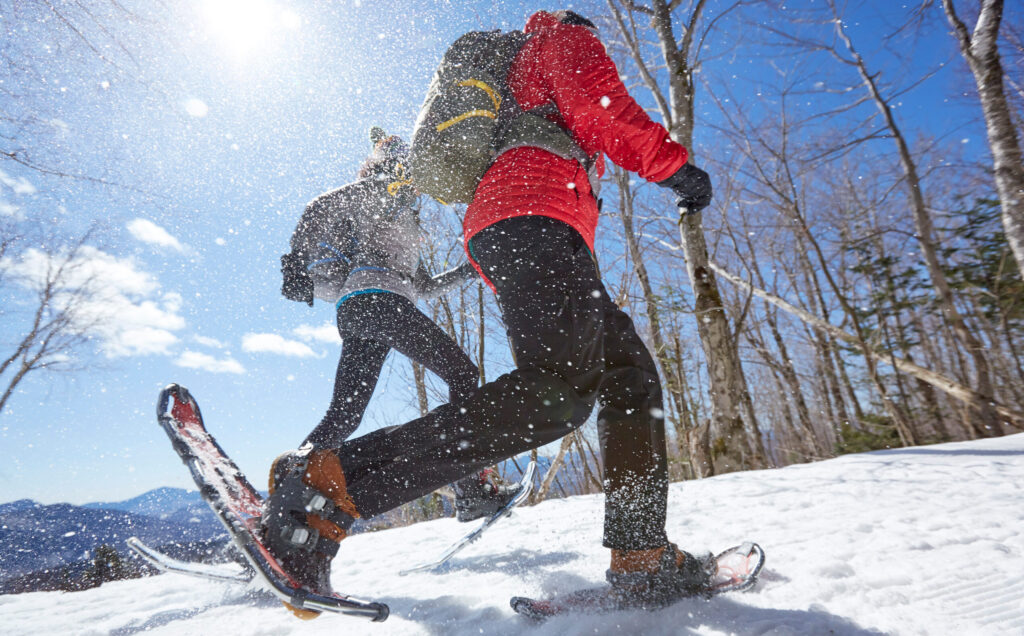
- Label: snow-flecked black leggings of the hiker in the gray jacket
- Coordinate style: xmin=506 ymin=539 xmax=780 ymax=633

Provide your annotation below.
xmin=303 ymin=292 xmax=479 ymax=449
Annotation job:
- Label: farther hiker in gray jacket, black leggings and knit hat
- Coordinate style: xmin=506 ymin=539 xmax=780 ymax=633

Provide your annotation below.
xmin=274 ymin=127 xmax=517 ymax=521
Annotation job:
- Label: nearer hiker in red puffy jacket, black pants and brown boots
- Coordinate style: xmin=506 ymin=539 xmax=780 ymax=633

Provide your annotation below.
xmin=263 ymin=7 xmax=712 ymax=614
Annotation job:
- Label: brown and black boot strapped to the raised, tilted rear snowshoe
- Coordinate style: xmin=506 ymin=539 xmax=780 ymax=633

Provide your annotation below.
xmin=261 ymin=449 xmax=359 ymax=619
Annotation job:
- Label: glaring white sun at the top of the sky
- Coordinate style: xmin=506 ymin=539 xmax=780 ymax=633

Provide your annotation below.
xmin=201 ymin=0 xmax=302 ymax=58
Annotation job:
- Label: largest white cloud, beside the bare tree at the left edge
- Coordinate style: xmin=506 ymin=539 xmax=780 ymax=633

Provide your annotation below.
xmin=0 ymin=246 xmax=185 ymax=357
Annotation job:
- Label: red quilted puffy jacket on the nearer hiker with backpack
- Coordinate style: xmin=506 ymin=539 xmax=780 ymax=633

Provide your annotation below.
xmin=463 ymin=11 xmax=687 ymax=264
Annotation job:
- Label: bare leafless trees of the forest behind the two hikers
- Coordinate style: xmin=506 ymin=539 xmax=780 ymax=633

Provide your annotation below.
xmin=0 ymin=0 xmax=1024 ymax=510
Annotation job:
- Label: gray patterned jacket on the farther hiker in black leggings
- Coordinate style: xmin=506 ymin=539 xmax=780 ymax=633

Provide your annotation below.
xmin=291 ymin=176 xmax=476 ymax=303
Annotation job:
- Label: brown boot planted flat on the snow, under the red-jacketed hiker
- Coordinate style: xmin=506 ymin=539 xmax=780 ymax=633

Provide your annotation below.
xmin=606 ymin=543 xmax=717 ymax=608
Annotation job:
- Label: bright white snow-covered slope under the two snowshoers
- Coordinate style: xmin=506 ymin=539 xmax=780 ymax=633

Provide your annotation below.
xmin=0 ymin=434 xmax=1024 ymax=635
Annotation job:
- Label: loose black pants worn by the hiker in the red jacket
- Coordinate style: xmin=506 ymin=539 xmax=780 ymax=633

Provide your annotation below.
xmin=339 ymin=216 xmax=668 ymax=550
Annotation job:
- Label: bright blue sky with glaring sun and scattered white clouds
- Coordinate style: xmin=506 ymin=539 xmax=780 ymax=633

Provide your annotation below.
xmin=0 ymin=0 xmax=983 ymax=503
